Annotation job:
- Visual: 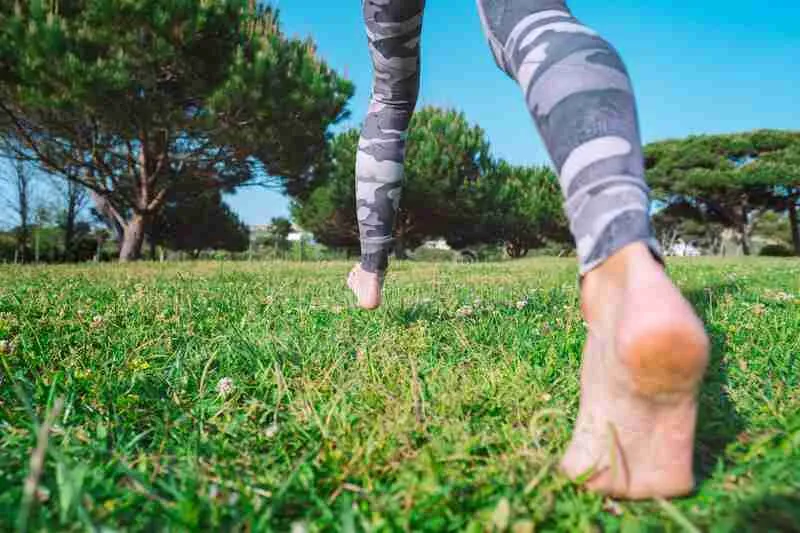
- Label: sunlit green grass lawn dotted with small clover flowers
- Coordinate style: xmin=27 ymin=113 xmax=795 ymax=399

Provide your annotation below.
xmin=0 ymin=259 xmax=800 ymax=532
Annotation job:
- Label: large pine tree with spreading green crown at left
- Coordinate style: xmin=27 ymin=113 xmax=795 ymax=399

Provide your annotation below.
xmin=0 ymin=0 xmax=353 ymax=258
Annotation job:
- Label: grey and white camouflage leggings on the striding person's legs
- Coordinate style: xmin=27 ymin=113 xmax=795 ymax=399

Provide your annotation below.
xmin=356 ymin=0 xmax=659 ymax=274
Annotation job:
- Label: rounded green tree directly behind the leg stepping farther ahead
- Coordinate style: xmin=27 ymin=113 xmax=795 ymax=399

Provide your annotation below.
xmin=293 ymin=107 xmax=490 ymax=255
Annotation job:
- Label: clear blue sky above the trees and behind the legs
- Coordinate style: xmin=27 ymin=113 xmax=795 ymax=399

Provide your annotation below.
xmin=223 ymin=0 xmax=788 ymax=224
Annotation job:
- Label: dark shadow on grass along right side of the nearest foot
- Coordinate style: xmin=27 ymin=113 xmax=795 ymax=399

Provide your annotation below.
xmin=684 ymin=283 xmax=745 ymax=482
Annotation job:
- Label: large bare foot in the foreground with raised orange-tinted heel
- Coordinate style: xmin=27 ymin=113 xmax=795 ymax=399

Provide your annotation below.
xmin=561 ymin=244 xmax=709 ymax=499
